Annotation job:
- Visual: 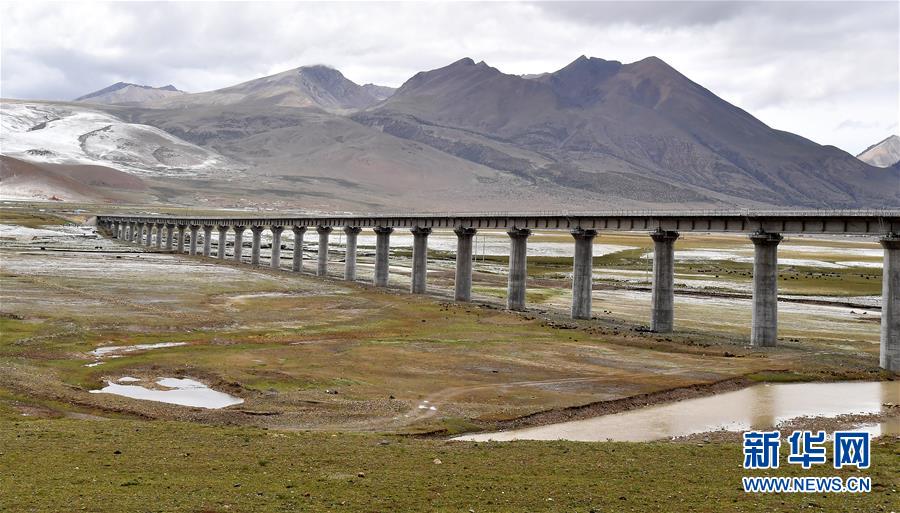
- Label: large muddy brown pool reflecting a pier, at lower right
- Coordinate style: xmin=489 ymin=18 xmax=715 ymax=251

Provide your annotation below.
xmin=455 ymin=381 xmax=900 ymax=442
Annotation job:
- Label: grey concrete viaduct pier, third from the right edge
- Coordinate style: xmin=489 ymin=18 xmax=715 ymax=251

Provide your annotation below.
xmin=650 ymin=230 xmax=678 ymax=333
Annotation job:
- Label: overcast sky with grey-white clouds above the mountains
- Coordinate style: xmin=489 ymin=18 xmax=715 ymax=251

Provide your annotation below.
xmin=0 ymin=0 xmax=900 ymax=153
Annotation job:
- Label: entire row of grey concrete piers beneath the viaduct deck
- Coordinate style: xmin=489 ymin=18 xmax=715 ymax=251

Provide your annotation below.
xmin=102 ymin=221 xmax=900 ymax=372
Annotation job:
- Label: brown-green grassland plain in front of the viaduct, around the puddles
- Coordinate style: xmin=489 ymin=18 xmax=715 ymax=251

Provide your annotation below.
xmin=0 ymin=203 xmax=900 ymax=511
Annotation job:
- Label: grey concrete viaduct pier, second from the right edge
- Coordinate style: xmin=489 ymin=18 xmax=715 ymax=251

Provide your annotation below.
xmin=750 ymin=232 xmax=783 ymax=347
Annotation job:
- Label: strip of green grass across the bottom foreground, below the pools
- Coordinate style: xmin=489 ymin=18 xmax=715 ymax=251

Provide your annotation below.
xmin=0 ymin=419 xmax=900 ymax=513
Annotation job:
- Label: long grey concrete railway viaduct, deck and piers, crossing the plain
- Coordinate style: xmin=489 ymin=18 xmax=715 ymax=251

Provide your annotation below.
xmin=97 ymin=210 xmax=900 ymax=373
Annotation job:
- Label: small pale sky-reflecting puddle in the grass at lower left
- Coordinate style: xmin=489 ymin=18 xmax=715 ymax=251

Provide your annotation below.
xmin=91 ymin=376 xmax=244 ymax=409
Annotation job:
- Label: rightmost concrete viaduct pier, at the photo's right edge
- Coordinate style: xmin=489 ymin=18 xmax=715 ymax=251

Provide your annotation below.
xmin=878 ymin=234 xmax=900 ymax=373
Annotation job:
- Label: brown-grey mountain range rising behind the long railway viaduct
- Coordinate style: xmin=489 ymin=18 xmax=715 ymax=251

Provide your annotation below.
xmin=3 ymin=56 xmax=900 ymax=210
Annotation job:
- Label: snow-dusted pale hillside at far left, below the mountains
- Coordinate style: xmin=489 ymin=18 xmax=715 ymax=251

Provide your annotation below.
xmin=0 ymin=100 xmax=235 ymax=177
